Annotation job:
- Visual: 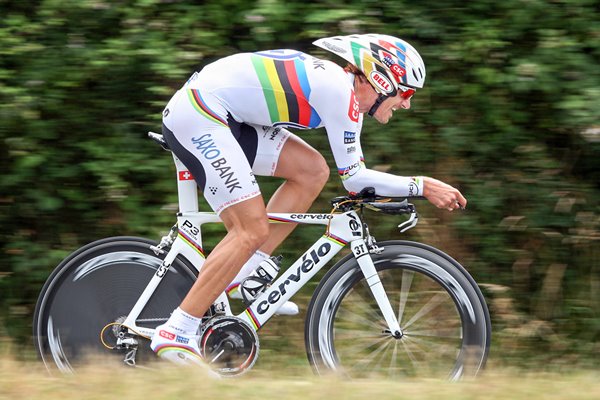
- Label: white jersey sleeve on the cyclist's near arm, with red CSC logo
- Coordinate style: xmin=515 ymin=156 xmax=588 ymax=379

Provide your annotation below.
xmin=316 ymin=67 xmax=423 ymax=197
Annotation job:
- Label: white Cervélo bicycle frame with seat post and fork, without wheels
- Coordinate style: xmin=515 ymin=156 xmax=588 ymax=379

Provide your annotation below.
xmin=123 ymin=150 xmax=401 ymax=337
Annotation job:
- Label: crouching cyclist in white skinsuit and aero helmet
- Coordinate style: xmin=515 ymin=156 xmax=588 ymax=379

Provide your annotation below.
xmin=151 ymin=34 xmax=467 ymax=363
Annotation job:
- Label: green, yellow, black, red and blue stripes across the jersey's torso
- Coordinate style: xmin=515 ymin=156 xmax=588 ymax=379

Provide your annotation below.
xmin=251 ymin=54 xmax=321 ymax=128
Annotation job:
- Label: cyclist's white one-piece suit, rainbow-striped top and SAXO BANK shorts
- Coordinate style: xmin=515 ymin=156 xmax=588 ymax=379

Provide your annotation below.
xmin=163 ymin=50 xmax=422 ymax=212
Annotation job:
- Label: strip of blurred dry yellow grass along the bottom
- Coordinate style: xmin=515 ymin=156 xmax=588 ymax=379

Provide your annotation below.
xmin=0 ymin=357 xmax=600 ymax=400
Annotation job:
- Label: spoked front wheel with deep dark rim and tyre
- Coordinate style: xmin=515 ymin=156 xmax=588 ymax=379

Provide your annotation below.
xmin=305 ymin=241 xmax=491 ymax=380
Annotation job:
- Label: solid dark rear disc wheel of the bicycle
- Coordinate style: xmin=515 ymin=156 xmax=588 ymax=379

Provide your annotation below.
xmin=33 ymin=236 xmax=196 ymax=372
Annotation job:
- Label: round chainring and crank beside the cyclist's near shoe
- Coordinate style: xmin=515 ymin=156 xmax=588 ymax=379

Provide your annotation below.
xmin=200 ymin=316 xmax=260 ymax=377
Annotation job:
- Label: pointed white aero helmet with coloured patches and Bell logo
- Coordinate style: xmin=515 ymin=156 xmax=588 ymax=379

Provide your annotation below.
xmin=313 ymin=34 xmax=425 ymax=96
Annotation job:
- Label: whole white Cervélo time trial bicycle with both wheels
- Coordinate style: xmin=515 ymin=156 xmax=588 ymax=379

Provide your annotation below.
xmin=33 ymin=132 xmax=491 ymax=380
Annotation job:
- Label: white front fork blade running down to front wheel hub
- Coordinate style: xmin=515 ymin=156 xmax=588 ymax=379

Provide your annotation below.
xmin=350 ymin=239 xmax=402 ymax=339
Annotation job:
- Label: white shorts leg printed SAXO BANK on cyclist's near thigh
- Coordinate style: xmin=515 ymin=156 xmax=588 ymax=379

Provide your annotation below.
xmin=163 ymin=89 xmax=260 ymax=213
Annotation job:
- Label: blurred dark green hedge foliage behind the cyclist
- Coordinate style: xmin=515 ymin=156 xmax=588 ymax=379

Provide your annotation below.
xmin=0 ymin=0 xmax=600 ymax=363
